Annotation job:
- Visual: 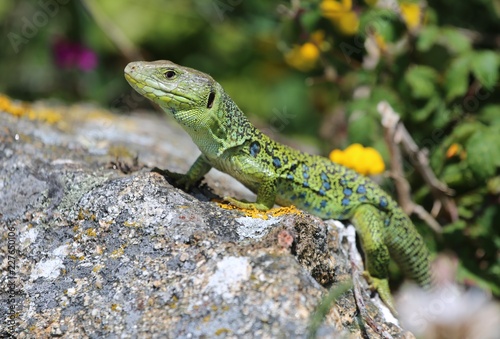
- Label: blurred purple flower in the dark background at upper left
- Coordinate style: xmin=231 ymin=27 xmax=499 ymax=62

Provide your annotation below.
xmin=52 ymin=39 xmax=97 ymax=72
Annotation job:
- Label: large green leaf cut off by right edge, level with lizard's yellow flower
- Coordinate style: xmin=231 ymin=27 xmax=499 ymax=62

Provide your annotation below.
xmin=465 ymin=128 xmax=500 ymax=180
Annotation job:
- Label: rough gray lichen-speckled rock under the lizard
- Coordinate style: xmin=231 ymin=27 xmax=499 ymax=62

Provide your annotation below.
xmin=0 ymin=98 xmax=404 ymax=338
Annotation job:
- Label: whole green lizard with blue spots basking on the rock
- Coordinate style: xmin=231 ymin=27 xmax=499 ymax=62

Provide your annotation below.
xmin=125 ymin=61 xmax=431 ymax=314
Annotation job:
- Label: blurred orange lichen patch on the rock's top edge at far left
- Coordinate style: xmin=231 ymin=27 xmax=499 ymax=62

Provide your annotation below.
xmin=0 ymin=94 xmax=62 ymax=124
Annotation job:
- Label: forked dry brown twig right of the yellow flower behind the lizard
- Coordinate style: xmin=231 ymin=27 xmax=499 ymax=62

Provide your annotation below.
xmin=377 ymin=101 xmax=458 ymax=233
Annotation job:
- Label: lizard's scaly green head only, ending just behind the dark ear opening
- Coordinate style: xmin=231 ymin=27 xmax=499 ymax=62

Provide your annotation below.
xmin=125 ymin=60 xmax=223 ymax=127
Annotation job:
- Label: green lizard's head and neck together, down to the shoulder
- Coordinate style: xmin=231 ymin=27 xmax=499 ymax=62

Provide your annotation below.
xmin=125 ymin=60 xmax=254 ymax=154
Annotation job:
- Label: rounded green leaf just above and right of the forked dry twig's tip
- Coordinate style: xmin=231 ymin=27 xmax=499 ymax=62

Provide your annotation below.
xmin=405 ymin=65 xmax=438 ymax=99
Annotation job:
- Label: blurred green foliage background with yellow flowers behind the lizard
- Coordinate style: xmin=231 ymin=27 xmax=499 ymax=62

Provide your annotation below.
xmin=0 ymin=0 xmax=500 ymax=295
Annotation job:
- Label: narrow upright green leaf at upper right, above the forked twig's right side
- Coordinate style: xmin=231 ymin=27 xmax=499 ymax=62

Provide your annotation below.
xmin=444 ymin=54 xmax=470 ymax=101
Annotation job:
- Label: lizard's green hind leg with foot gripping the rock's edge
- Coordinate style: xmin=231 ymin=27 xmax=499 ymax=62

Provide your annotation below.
xmin=351 ymin=204 xmax=397 ymax=315
